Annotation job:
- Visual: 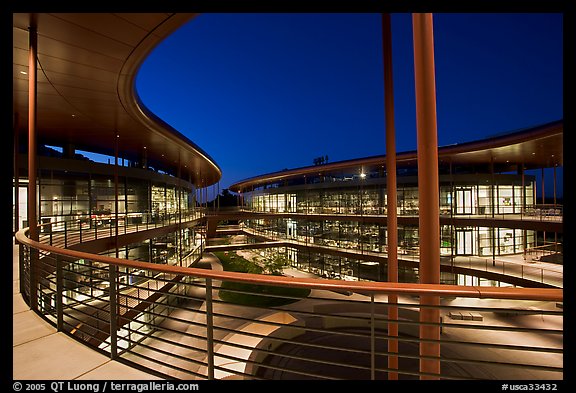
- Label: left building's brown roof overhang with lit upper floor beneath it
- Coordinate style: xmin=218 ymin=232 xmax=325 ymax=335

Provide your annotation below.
xmin=13 ymin=13 xmax=221 ymax=254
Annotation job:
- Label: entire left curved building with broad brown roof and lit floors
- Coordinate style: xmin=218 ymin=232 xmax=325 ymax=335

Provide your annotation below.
xmin=13 ymin=13 xmax=221 ymax=362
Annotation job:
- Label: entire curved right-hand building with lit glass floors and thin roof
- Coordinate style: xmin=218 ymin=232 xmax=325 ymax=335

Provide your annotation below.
xmin=231 ymin=120 xmax=563 ymax=285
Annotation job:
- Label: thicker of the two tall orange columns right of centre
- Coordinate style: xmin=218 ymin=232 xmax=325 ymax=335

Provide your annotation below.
xmin=412 ymin=14 xmax=440 ymax=379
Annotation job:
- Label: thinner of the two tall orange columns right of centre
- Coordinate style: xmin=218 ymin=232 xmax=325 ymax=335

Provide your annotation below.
xmin=382 ymin=14 xmax=398 ymax=379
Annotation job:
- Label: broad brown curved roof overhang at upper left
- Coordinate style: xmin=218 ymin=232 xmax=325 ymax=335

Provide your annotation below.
xmin=12 ymin=13 xmax=222 ymax=187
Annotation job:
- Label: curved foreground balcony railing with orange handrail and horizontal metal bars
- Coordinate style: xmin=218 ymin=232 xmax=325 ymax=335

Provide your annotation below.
xmin=16 ymin=224 xmax=563 ymax=380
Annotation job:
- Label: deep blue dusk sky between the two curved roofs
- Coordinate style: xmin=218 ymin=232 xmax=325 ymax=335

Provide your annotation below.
xmin=137 ymin=13 xmax=563 ymax=193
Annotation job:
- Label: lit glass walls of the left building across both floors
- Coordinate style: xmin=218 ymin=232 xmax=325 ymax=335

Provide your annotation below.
xmin=13 ymin=151 xmax=206 ymax=316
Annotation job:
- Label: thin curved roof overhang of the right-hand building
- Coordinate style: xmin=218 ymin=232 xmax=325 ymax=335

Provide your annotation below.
xmin=230 ymin=120 xmax=564 ymax=192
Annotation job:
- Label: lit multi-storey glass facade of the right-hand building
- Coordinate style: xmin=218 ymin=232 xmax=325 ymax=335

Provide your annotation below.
xmin=237 ymin=173 xmax=537 ymax=281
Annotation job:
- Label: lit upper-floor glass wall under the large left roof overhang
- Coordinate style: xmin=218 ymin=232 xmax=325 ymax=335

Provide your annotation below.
xmin=13 ymin=171 xmax=196 ymax=231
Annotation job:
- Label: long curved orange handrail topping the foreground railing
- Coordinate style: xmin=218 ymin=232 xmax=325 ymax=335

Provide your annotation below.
xmin=15 ymin=228 xmax=563 ymax=302
